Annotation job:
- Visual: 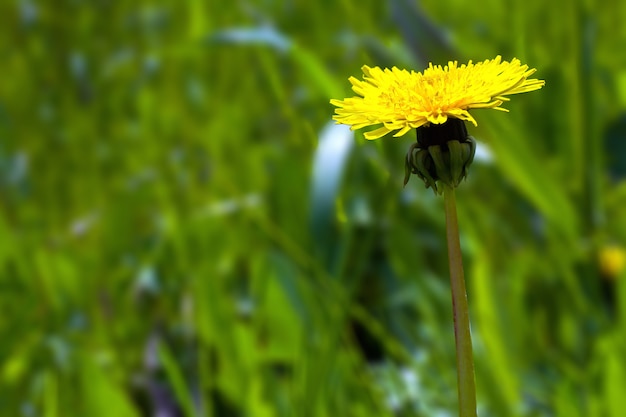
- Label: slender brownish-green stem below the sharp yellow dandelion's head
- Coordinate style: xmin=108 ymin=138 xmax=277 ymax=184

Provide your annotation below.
xmin=444 ymin=185 xmax=476 ymax=417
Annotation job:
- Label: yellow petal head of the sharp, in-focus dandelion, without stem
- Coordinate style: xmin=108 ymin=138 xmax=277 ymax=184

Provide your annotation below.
xmin=330 ymin=56 xmax=545 ymax=139
